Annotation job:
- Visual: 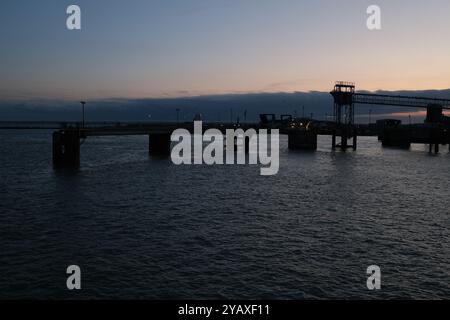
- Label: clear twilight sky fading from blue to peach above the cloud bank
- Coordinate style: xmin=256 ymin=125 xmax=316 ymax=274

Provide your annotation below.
xmin=0 ymin=0 xmax=450 ymax=100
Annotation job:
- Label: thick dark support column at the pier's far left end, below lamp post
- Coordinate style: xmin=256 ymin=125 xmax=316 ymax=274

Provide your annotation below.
xmin=53 ymin=130 xmax=80 ymax=168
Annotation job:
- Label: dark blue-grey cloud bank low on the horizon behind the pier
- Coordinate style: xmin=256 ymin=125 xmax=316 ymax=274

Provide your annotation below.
xmin=0 ymin=89 xmax=450 ymax=122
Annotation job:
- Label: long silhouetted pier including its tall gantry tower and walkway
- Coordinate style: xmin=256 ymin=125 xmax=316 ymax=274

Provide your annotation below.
xmin=0 ymin=81 xmax=450 ymax=167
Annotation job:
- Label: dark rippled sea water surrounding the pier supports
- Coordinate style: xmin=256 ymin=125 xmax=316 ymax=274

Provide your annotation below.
xmin=0 ymin=131 xmax=450 ymax=299
